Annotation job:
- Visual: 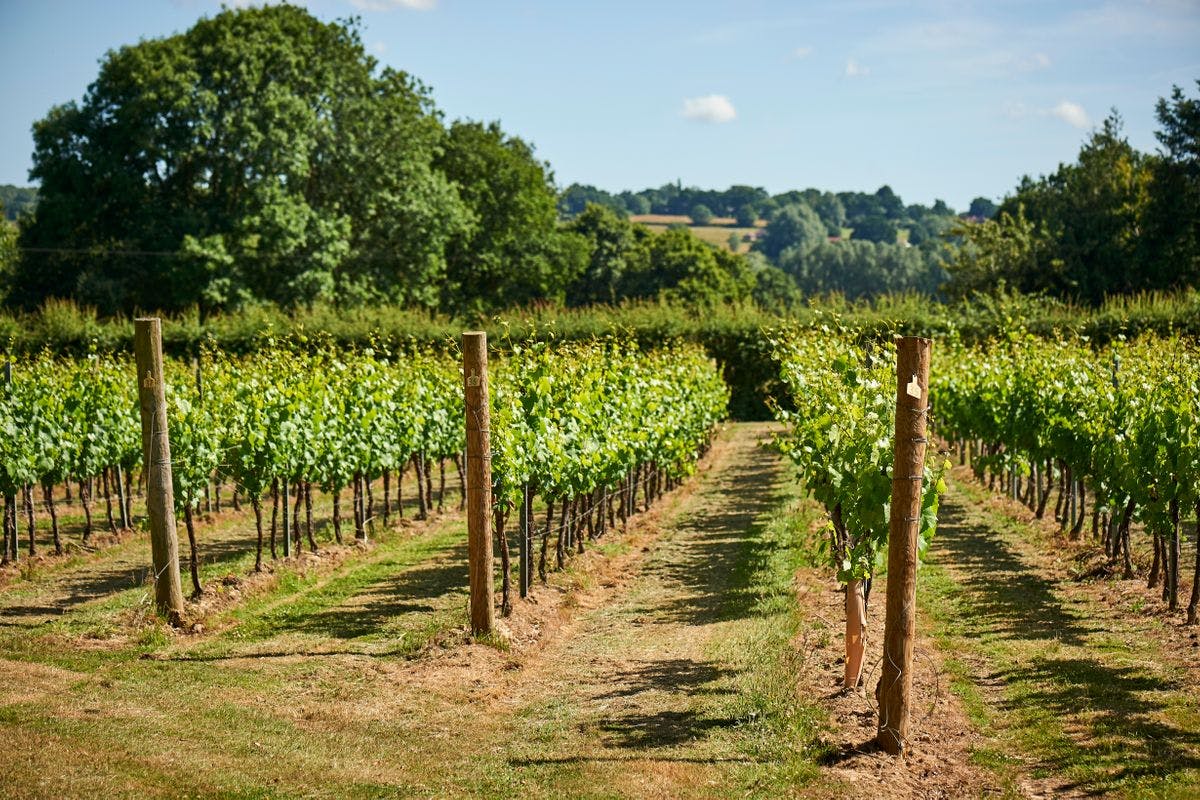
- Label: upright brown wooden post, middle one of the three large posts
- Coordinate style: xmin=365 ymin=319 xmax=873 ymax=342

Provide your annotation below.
xmin=462 ymin=331 xmax=496 ymax=634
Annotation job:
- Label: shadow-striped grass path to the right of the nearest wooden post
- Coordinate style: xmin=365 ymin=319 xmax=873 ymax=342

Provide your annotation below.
xmin=918 ymin=480 xmax=1200 ymax=798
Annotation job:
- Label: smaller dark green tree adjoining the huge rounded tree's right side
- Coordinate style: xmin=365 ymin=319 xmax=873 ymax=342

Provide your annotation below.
xmin=434 ymin=122 xmax=586 ymax=312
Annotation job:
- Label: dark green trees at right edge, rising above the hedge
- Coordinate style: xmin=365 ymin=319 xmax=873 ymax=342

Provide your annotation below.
xmin=946 ymin=80 xmax=1200 ymax=305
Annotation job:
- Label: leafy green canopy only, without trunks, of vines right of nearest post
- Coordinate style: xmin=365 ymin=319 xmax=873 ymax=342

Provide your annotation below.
xmin=931 ymin=332 xmax=1200 ymax=546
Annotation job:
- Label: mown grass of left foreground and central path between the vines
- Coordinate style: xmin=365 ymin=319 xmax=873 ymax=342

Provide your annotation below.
xmin=0 ymin=426 xmax=820 ymax=798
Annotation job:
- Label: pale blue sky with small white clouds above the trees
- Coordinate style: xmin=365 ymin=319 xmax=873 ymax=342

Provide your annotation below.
xmin=0 ymin=0 xmax=1200 ymax=210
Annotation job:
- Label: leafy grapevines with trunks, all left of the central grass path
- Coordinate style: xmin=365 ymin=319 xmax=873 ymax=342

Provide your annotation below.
xmin=0 ymin=341 xmax=728 ymax=603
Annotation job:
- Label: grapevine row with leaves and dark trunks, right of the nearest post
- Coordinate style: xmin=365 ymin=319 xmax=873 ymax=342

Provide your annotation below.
xmin=932 ymin=333 xmax=1200 ymax=624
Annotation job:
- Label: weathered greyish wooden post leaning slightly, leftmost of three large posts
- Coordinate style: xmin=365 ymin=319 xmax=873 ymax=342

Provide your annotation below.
xmin=133 ymin=318 xmax=184 ymax=625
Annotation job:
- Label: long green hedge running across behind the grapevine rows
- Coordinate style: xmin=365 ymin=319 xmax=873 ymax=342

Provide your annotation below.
xmin=9 ymin=291 xmax=1200 ymax=419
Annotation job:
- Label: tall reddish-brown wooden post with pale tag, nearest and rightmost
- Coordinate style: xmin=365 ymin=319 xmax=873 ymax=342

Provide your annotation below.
xmin=875 ymin=336 xmax=932 ymax=756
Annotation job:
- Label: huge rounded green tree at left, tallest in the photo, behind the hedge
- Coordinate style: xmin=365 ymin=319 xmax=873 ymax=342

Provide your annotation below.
xmin=14 ymin=5 xmax=468 ymax=312
